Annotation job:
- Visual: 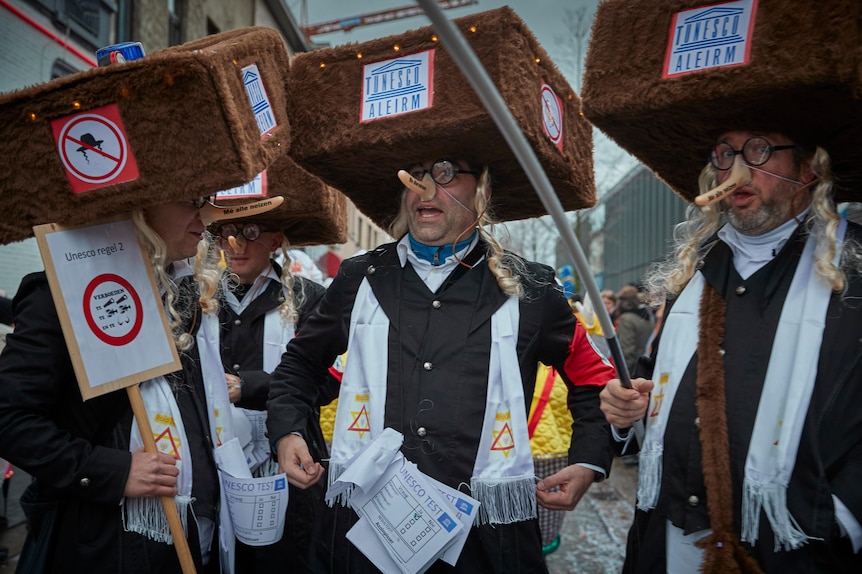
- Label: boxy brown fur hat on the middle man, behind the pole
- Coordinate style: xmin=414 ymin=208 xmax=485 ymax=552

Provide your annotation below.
xmin=288 ymin=8 xmax=595 ymax=229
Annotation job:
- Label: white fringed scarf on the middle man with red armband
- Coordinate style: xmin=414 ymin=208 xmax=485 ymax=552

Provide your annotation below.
xmin=329 ymin=274 xmax=536 ymax=524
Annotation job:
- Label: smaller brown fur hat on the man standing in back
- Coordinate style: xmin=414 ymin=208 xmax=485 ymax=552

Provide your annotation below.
xmin=210 ymin=155 xmax=347 ymax=247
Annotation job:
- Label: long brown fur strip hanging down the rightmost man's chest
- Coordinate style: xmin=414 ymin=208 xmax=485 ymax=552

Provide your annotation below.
xmin=696 ymin=283 xmax=761 ymax=574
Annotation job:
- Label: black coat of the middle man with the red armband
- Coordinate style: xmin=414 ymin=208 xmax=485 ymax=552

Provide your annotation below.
xmin=268 ymin=244 xmax=611 ymax=573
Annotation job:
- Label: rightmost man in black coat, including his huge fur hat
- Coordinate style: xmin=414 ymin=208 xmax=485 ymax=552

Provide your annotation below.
xmin=584 ymin=0 xmax=862 ymax=573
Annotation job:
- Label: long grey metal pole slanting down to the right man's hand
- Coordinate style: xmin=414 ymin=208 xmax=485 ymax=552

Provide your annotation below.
xmin=417 ymin=0 xmax=644 ymax=444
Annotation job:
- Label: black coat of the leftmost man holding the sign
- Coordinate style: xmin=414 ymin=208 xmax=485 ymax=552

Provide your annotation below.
xmin=0 ymin=273 xmax=218 ymax=574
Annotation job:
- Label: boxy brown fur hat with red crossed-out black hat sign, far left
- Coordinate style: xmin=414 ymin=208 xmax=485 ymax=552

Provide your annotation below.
xmin=0 ymin=28 xmax=289 ymax=243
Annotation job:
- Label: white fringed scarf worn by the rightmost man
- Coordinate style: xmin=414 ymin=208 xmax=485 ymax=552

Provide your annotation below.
xmin=638 ymin=219 xmax=847 ymax=550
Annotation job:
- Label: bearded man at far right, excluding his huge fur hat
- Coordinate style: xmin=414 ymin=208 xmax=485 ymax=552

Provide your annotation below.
xmin=602 ymin=130 xmax=862 ymax=572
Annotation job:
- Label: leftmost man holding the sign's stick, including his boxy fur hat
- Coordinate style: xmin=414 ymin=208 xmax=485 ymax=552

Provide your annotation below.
xmin=0 ymin=29 xmax=296 ymax=573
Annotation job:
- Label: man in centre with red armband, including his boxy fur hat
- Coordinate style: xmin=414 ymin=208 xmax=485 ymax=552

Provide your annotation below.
xmin=268 ymin=9 xmax=613 ymax=572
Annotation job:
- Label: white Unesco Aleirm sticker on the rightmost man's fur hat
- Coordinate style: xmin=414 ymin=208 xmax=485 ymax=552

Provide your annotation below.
xmin=662 ymin=0 xmax=757 ymax=78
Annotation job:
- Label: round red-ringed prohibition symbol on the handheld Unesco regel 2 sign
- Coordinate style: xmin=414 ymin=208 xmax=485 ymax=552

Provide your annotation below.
xmin=83 ymin=273 xmax=144 ymax=347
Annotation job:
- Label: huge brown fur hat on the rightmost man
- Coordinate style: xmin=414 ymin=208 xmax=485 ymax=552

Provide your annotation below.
xmin=583 ymin=0 xmax=862 ymax=201
